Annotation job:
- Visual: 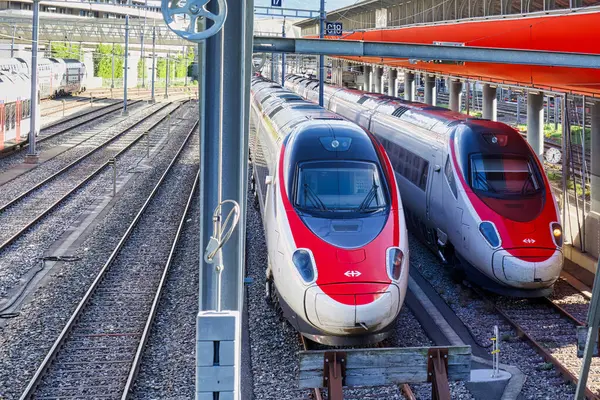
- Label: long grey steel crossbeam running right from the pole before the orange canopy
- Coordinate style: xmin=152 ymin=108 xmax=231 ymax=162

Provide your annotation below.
xmin=254 ymin=36 xmax=600 ymax=69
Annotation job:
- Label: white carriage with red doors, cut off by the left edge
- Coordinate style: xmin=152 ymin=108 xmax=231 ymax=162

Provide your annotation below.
xmin=0 ymin=73 xmax=39 ymax=150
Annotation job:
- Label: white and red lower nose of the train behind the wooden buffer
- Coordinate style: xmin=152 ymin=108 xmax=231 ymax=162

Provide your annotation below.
xmin=304 ymin=283 xmax=400 ymax=335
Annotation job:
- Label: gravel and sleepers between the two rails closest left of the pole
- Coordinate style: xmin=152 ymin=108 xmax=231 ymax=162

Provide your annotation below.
xmin=31 ymin=118 xmax=199 ymax=398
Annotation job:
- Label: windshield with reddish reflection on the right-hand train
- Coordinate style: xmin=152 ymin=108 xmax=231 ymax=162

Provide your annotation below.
xmin=471 ymin=155 xmax=541 ymax=197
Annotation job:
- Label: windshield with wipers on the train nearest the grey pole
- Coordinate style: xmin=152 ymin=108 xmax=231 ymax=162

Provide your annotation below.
xmin=294 ymin=161 xmax=388 ymax=216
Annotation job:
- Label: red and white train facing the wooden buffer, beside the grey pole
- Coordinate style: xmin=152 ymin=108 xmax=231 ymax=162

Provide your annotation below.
xmin=250 ymin=78 xmax=409 ymax=345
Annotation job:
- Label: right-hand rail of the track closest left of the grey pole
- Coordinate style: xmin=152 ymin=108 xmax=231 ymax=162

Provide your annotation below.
xmin=121 ymin=171 xmax=200 ymax=400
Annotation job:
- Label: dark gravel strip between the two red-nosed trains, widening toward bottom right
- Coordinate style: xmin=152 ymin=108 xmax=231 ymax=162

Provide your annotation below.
xmin=410 ymin=235 xmax=575 ymax=400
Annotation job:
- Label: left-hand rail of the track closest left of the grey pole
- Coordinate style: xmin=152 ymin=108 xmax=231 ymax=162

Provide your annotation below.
xmin=20 ymin=120 xmax=198 ymax=400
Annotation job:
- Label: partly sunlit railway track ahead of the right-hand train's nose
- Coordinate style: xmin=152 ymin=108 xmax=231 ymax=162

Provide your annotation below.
xmin=474 ymin=279 xmax=600 ymax=400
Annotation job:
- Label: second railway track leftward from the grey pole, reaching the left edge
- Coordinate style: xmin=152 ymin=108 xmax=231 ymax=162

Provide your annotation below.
xmin=0 ymin=104 xmax=182 ymax=251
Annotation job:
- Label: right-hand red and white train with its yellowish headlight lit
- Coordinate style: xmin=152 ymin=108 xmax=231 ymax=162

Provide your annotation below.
xmin=286 ymin=75 xmax=563 ymax=297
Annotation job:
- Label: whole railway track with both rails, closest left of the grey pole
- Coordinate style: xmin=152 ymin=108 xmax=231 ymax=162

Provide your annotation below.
xmin=21 ymin=122 xmax=198 ymax=400
